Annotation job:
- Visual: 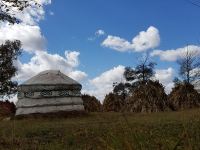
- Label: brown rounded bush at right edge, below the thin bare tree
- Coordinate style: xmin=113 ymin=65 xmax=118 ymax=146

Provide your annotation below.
xmin=169 ymin=83 xmax=200 ymax=110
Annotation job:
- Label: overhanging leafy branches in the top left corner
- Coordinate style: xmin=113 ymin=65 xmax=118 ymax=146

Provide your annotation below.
xmin=0 ymin=0 xmax=40 ymax=24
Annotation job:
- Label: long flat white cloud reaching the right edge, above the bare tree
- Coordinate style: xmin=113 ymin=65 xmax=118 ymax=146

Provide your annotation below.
xmin=150 ymin=45 xmax=200 ymax=61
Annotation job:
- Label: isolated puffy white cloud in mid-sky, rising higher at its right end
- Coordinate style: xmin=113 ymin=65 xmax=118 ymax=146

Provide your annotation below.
xmin=101 ymin=26 xmax=160 ymax=52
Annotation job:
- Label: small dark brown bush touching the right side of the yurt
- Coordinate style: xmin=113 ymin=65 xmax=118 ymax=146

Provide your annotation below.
xmin=82 ymin=95 xmax=102 ymax=112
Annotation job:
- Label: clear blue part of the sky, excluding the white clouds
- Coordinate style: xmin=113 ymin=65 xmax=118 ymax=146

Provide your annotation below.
xmin=40 ymin=0 xmax=200 ymax=77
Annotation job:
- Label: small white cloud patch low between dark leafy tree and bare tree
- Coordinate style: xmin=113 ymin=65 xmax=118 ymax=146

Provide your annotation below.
xmin=155 ymin=67 xmax=175 ymax=93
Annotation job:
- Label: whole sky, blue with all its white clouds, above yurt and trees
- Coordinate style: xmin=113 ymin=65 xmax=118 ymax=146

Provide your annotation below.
xmin=0 ymin=0 xmax=200 ymax=100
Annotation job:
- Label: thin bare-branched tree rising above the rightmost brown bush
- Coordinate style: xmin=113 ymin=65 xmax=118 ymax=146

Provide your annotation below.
xmin=177 ymin=48 xmax=200 ymax=84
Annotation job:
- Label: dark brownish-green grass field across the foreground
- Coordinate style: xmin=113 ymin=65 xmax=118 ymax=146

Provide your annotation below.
xmin=0 ymin=109 xmax=200 ymax=150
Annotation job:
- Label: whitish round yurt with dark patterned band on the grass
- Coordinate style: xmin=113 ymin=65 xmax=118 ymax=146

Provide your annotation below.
xmin=16 ymin=70 xmax=84 ymax=115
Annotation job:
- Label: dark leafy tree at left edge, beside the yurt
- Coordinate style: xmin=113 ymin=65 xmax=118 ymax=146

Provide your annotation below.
xmin=0 ymin=40 xmax=21 ymax=97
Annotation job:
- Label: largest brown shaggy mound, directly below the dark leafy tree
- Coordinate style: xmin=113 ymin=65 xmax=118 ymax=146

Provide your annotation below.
xmin=126 ymin=80 xmax=167 ymax=112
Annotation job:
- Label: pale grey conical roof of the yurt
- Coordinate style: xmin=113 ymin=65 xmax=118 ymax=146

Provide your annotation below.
xmin=19 ymin=70 xmax=81 ymax=91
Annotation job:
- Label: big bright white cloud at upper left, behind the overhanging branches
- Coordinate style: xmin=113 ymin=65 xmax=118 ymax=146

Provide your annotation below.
xmin=0 ymin=0 xmax=51 ymax=52
